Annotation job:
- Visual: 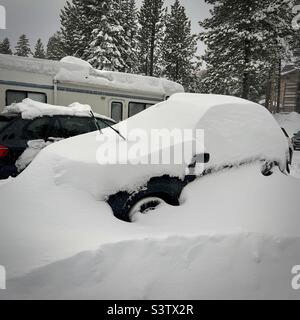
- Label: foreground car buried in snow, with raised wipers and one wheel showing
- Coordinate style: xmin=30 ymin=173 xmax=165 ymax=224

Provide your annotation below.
xmin=36 ymin=94 xmax=289 ymax=221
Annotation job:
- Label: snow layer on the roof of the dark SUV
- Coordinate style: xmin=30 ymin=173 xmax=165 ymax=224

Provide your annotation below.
xmin=2 ymin=98 xmax=114 ymax=121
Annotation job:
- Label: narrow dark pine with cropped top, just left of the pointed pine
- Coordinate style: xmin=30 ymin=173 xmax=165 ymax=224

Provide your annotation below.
xmin=139 ymin=0 xmax=164 ymax=76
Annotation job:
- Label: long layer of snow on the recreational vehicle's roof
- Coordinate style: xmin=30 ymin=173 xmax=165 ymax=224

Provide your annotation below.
xmin=0 ymin=54 xmax=184 ymax=97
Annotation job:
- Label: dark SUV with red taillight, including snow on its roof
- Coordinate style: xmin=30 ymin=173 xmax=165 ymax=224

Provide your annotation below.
xmin=0 ymin=99 xmax=115 ymax=179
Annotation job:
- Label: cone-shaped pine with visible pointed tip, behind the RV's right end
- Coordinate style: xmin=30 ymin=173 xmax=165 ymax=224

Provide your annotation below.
xmin=163 ymin=0 xmax=197 ymax=91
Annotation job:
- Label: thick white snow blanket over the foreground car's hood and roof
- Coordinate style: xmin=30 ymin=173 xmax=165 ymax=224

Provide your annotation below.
xmin=32 ymin=94 xmax=288 ymax=199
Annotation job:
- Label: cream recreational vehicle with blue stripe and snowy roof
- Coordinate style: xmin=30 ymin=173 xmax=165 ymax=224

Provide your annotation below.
xmin=0 ymin=54 xmax=184 ymax=122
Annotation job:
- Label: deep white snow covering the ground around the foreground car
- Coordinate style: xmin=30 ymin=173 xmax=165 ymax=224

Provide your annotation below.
xmin=0 ymin=109 xmax=300 ymax=299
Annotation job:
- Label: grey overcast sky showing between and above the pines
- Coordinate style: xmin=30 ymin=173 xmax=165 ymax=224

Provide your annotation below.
xmin=0 ymin=0 xmax=209 ymax=52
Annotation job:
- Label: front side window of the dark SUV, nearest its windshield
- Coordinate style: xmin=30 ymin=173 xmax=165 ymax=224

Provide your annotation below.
xmin=55 ymin=116 xmax=96 ymax=138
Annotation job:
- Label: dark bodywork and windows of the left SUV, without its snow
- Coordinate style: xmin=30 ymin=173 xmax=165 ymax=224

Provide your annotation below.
xmin=0 ymin=113 xmax=115 ymax=179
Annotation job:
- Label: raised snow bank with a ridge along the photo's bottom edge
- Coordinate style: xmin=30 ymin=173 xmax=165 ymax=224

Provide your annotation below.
xmin=3 ymin=233 xmax=300 ymax=300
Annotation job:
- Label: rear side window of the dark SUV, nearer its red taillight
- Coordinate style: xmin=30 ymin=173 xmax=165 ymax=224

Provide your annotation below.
xmin=23 ymin=117 xmax=51 ymax=140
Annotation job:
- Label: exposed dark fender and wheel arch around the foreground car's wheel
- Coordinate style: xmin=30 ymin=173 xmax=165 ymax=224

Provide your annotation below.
xmin=107 ymin=176 xmax=184 ymax=222
